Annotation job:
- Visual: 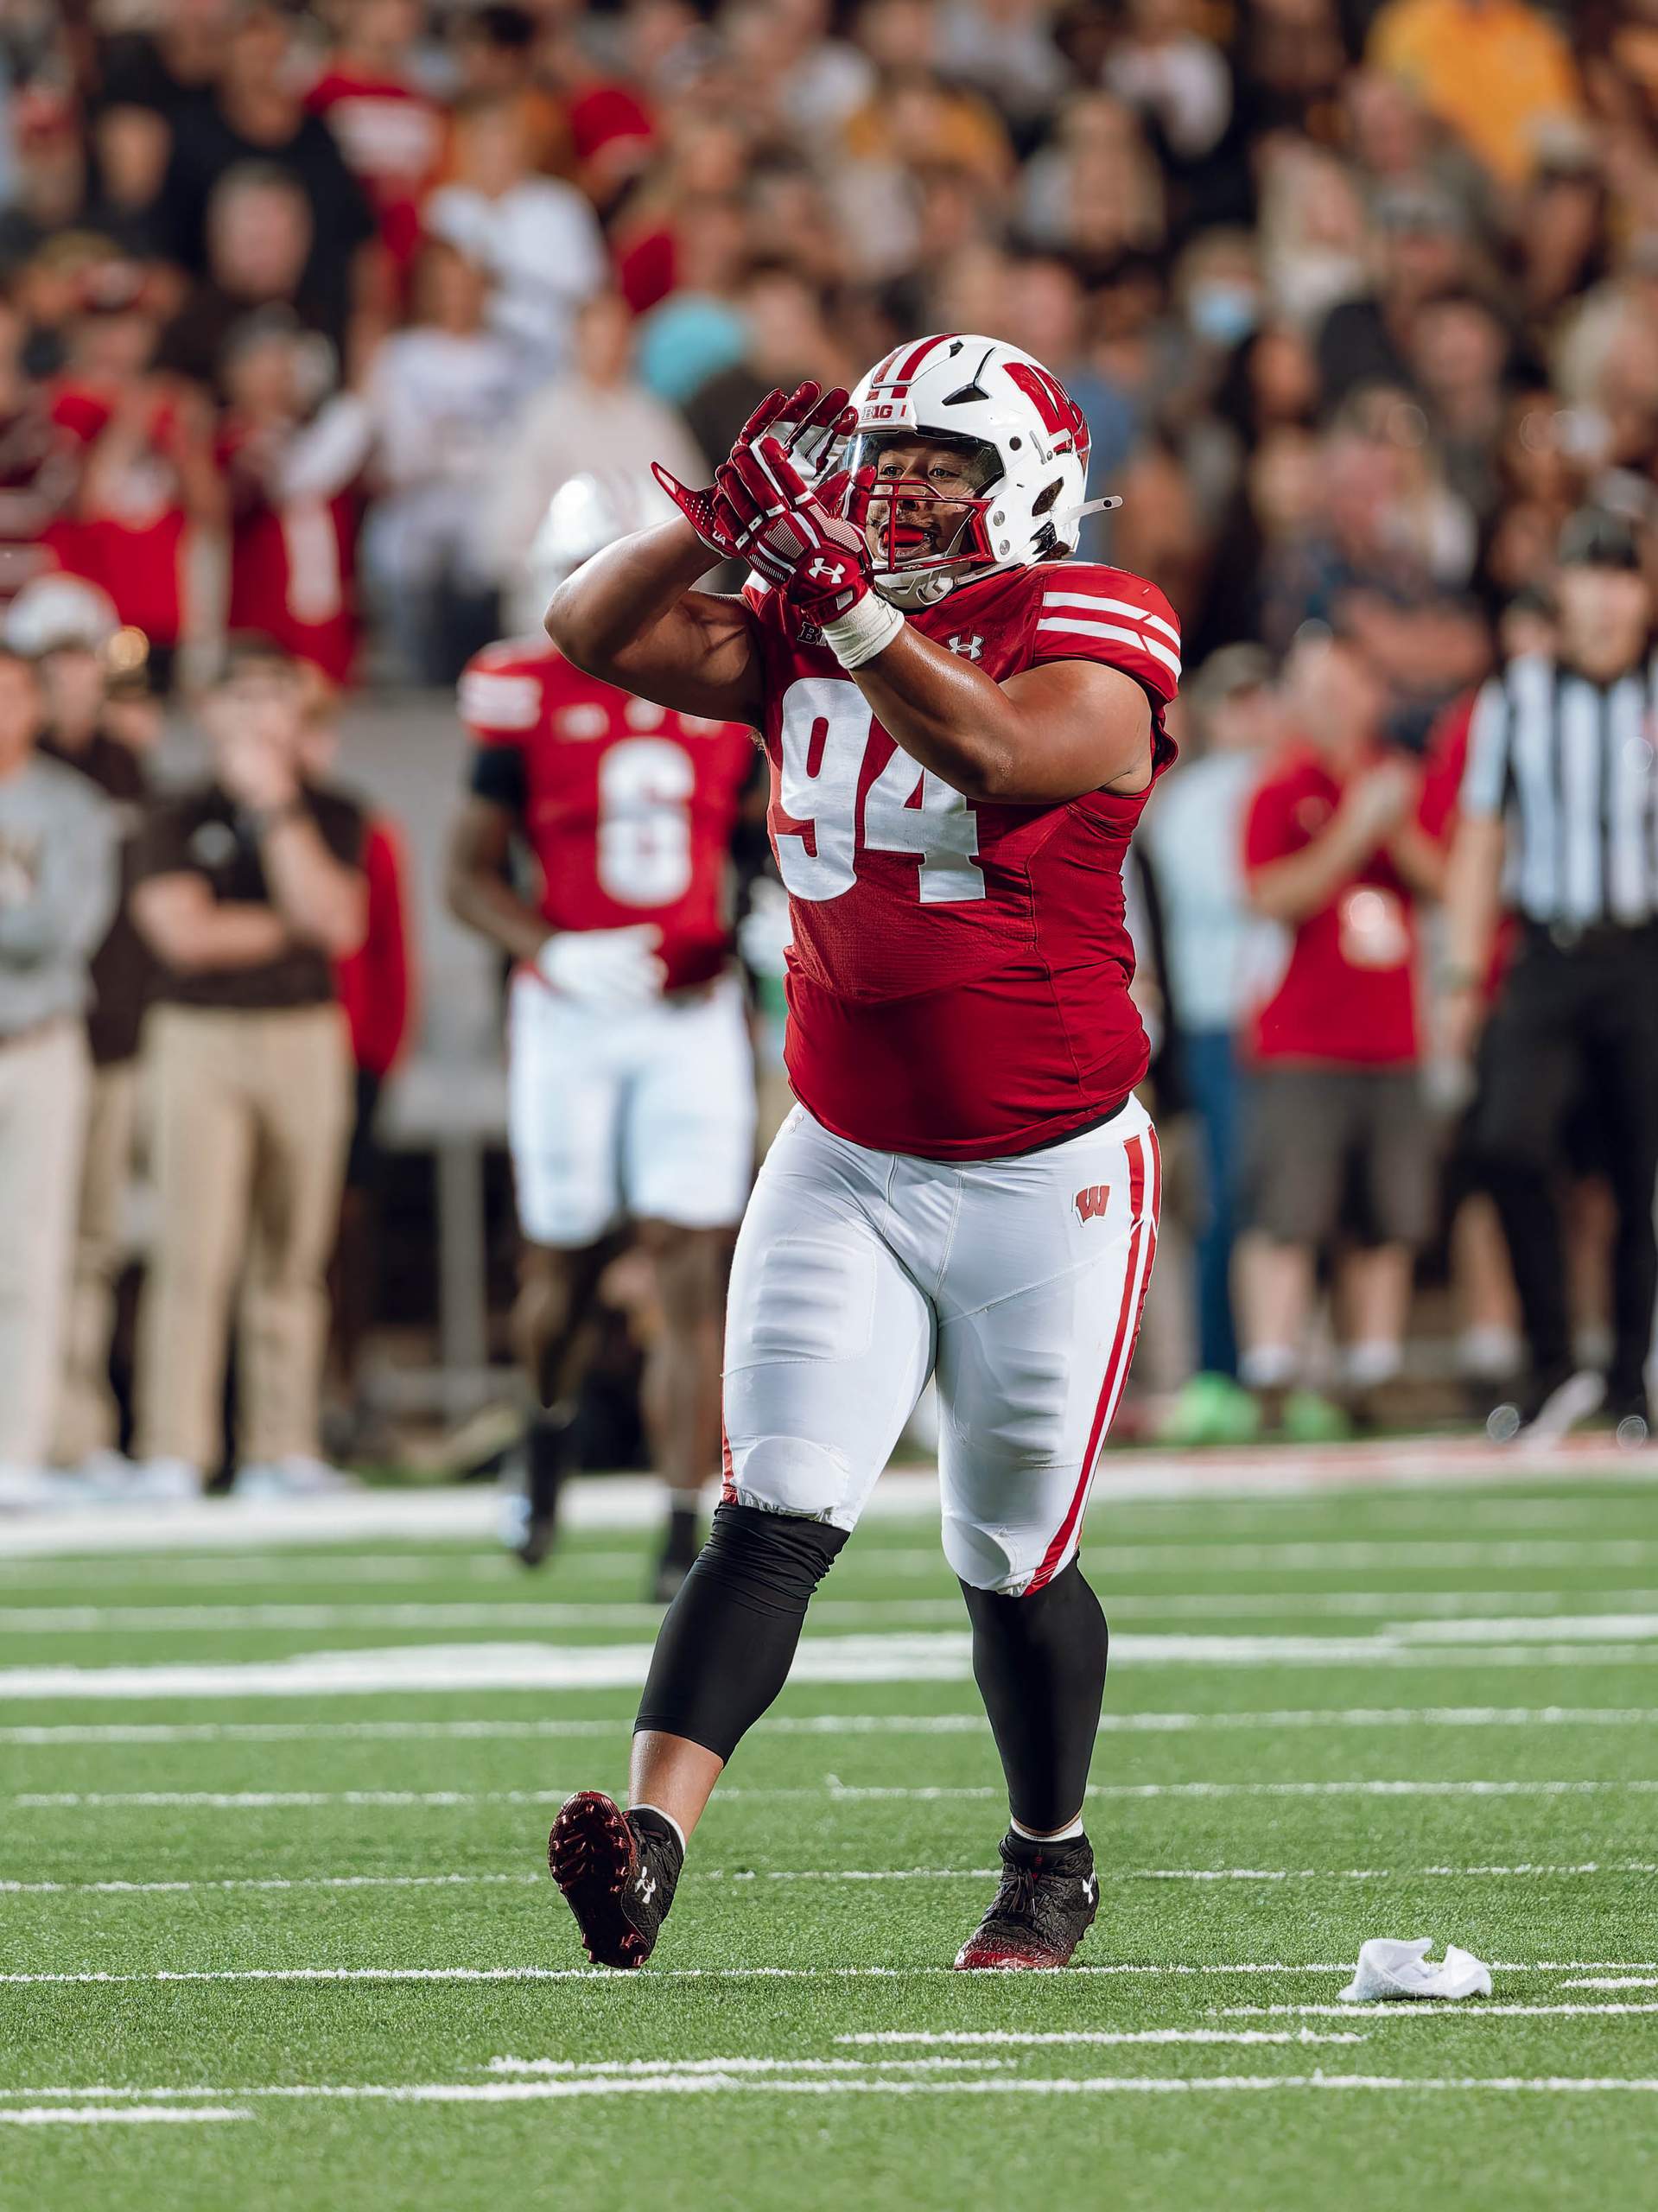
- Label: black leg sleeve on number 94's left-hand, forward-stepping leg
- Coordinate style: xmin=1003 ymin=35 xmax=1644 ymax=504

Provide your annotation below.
xmin=634 ymin=1504 xmax=847 ymax=1758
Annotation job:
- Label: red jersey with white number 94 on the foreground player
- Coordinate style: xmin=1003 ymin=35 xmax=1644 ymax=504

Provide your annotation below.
xmin=745 ymin=562 xmax=1180 ymax=1159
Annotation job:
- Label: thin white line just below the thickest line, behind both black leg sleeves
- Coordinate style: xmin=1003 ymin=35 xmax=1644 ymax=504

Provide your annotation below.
xmin=0 ymin=1706 xmax=1658 ymax=1750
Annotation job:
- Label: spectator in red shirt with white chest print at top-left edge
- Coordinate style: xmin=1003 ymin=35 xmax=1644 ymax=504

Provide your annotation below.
xmin=305 ymin=0 xmax=444 ymax=283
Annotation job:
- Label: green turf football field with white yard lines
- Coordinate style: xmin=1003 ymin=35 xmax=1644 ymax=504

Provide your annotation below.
xmin=0 ymin=1478 xmax=1658 ymax=2212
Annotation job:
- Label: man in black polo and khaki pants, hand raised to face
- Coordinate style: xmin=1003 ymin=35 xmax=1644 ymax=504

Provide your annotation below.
xmin=133 ymin=639 xmax=367 ymax=1496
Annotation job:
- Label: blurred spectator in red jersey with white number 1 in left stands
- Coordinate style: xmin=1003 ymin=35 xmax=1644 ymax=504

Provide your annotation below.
xmin=217 ymin=309 xmax=373 ymax=683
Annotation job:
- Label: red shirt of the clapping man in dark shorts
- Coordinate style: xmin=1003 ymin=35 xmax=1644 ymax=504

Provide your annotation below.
xmin=1245 ymin=746 xmax=1448 ymax=1068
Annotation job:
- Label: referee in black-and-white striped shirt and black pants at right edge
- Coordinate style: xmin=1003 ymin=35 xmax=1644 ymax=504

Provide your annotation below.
xmin=1444 ymin=509 xmax=1658 ymax=1445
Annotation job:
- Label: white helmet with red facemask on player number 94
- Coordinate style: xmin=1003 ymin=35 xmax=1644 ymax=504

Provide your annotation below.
xmin=824 ymin=332 xmax=1121 ymax=606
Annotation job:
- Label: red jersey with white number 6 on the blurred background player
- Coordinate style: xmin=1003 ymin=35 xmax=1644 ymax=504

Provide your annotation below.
xmin=460 ymin=639 xmax=754 ymax=991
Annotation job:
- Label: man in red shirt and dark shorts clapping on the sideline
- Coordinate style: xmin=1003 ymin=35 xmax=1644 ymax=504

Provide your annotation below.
xmin=1240 ymin=632 xmax=1444 ymax=1425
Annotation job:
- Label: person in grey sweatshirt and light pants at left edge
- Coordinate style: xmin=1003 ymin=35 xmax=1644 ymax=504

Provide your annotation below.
xmin=0 ymin=646 xmax=115 ymax=1504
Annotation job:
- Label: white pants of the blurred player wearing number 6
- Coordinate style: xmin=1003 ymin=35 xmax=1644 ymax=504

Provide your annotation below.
xmin=506 ymin=973 xmax=754 ymax=1245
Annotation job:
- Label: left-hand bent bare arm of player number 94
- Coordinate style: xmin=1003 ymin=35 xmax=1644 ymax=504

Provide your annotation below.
xmin=546 ymin=520 xmax=760 ymax=721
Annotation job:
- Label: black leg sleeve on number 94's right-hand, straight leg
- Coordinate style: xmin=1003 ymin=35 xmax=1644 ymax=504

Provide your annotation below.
xmin=962 ymin=1560 xmax=1108 ymax=1834
